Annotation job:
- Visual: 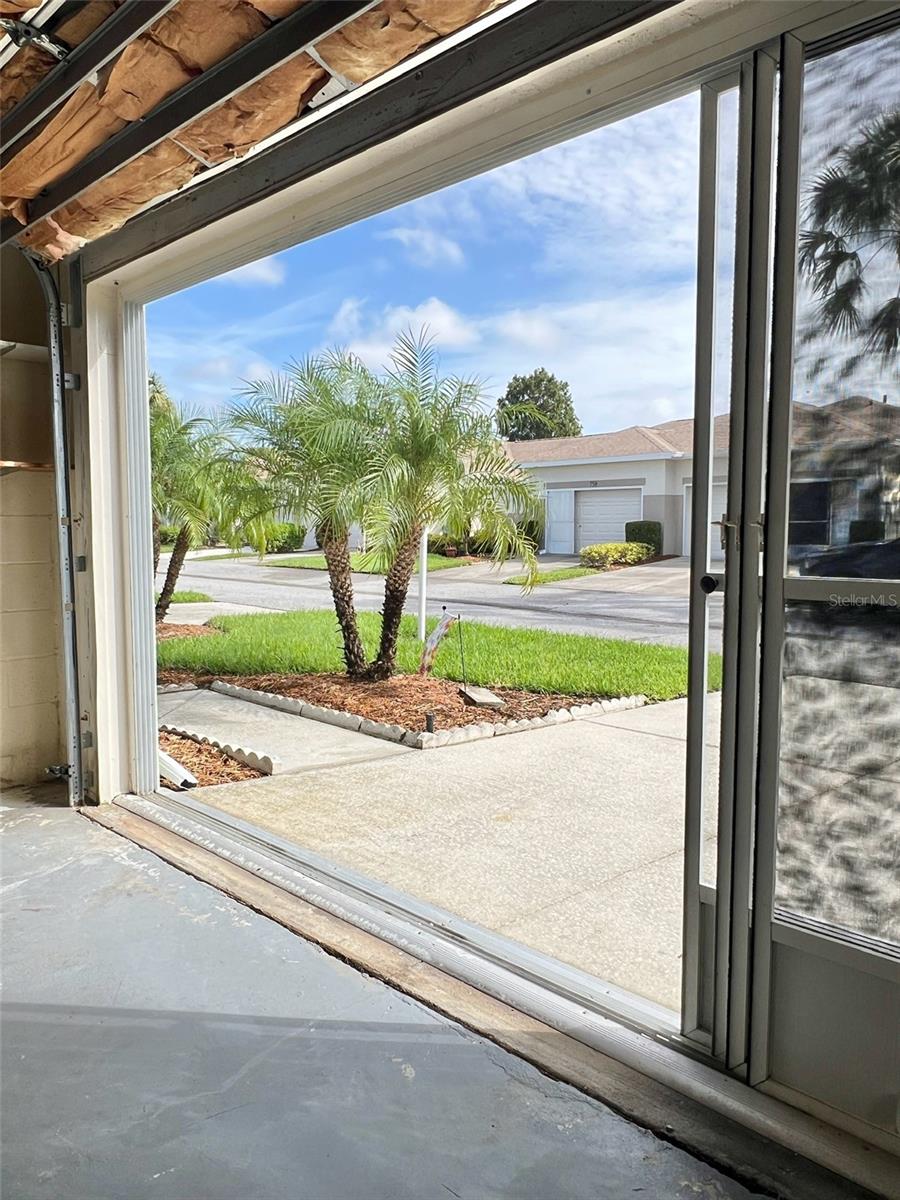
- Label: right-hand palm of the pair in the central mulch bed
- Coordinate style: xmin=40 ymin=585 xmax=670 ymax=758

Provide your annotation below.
xmin=365 ymin=331 xmax=542 ymax=679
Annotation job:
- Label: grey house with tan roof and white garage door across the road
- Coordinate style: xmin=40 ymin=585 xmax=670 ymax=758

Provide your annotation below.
xmin=506 ymin=396 xmax=900 ymax=559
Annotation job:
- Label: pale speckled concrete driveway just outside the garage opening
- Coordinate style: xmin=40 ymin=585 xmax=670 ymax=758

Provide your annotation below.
xmin=180 ymin=694 xmax=720 ymax=1009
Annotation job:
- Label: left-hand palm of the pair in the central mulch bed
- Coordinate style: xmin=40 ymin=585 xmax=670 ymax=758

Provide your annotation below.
xmin=230 ymin=350 xmax=380 ymax=677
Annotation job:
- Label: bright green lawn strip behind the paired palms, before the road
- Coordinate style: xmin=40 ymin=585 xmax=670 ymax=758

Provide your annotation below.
xmin=157 ymin=610 xmax=721 ymax=700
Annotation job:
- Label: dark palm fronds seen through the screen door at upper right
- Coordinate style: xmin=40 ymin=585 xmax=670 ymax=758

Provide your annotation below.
xmin=799 ymin=109 xmax=900 ymax=378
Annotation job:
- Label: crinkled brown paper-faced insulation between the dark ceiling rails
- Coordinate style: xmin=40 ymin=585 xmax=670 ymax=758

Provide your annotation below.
xmin=0 ymin=0 xmax=502 ymax=260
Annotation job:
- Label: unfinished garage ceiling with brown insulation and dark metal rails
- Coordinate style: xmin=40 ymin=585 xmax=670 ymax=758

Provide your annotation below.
xmin=0 ymin=0 xmax=520 ymax=258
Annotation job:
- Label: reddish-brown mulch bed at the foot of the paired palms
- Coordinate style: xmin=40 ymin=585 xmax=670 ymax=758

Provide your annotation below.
xmin=158 ymin=670 xmax=599 ymax=732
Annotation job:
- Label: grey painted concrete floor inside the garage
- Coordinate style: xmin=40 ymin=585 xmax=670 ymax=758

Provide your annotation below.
xmin=0 ymin=790 xmax=756 ymax=1200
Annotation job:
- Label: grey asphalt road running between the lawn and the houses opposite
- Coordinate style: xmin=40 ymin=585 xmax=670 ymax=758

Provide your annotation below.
xmin=161 ymin=549 xmax=721 ymax=649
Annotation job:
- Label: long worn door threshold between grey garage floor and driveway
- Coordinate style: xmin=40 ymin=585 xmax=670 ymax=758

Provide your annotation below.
xmin=80 ymin=796 xmax=896 ymax=1200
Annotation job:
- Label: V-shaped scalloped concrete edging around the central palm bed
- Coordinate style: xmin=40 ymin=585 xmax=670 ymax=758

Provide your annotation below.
xmin=207 ymin=679 xmax=647 ymax=744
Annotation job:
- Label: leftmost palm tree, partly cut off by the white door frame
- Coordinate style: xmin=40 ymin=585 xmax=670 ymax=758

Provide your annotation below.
xmin=150 ymin=393 xmax=221 ymax=623
